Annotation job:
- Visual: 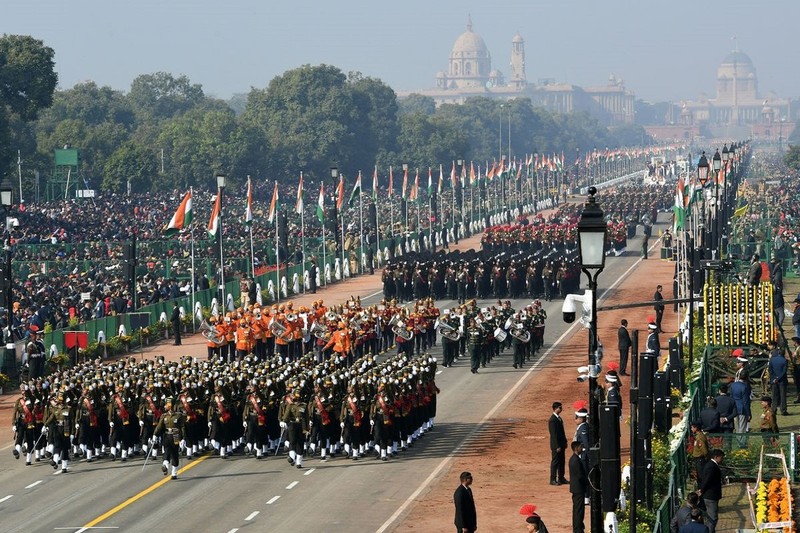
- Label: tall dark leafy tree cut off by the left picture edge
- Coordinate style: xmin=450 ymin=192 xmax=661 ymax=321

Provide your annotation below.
xmin=0 ymin=35 xmax=58 ymax=172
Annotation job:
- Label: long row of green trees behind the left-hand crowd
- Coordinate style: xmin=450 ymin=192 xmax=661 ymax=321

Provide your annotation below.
xmin=0 ymin=35 xmax=646 ymax=197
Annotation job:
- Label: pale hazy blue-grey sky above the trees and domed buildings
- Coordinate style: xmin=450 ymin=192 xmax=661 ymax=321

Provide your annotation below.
xmin=6 ymin=0 xmax=800 ymax=101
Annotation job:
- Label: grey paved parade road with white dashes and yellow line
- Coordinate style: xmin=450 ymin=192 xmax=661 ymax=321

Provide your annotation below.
xmin=0 ymin=228 xmax=656 ymax=533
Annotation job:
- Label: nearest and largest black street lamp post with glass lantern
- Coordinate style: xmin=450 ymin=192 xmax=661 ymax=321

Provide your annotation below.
xmin=578 ymin=187 xmax=608 ymax=532
